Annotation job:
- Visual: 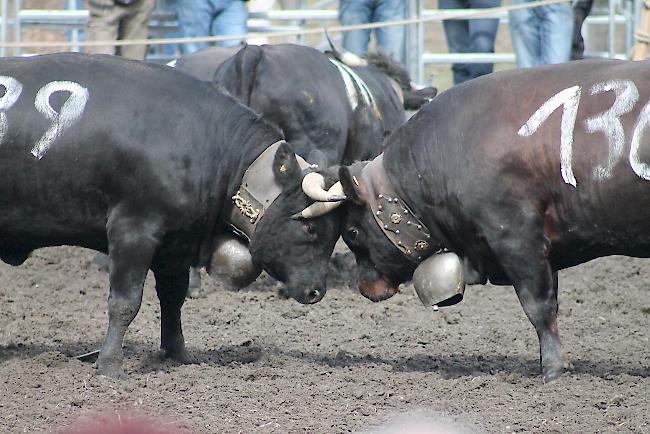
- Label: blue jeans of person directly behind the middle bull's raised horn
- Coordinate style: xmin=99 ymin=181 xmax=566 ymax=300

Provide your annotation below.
xmin=339 ymin=0 xmax=406 ymax=63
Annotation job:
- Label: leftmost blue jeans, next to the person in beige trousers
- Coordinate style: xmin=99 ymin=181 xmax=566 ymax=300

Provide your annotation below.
xmin=176 ymin=0 xmax=248 ymax=54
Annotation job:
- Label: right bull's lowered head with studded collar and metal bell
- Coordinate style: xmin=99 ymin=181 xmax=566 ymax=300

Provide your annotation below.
xmin=339 ymin=160 xmax=465 ymax=307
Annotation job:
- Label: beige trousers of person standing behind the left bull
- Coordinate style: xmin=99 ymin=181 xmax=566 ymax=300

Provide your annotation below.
xmin=85 ymin=0 xmax=155 ymax=60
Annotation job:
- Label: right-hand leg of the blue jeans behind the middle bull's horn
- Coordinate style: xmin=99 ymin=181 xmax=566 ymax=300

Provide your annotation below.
xmin=372 ymin=0 xmax=406 ymax=64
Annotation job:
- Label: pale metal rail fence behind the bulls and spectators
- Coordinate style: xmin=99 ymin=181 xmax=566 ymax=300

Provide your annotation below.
xmin=0 ymin=0 xmax=641 ymax=82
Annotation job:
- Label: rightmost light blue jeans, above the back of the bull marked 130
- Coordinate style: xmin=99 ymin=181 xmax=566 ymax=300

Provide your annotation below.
xmin=508 ymin=0 xmax=573 ymax=68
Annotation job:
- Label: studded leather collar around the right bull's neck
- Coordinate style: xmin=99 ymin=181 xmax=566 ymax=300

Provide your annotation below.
xmin=361 ymin=154 xmax=444 ymax=263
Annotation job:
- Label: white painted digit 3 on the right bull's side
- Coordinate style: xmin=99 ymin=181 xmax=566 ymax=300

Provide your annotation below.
xmin=585 ymin=80 xmax=639 ymax=179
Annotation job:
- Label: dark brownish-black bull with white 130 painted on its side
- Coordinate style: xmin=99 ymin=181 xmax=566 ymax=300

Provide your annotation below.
xmin=339 ymin=60 xmax=650 ymax=381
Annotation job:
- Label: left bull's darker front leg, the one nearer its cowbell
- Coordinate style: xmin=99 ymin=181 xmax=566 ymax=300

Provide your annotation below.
xmin=154 ymin=260 xmax=192 ymax=363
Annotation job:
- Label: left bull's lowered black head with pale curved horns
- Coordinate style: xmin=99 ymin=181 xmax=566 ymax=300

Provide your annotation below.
xmin=243 ymin=142 xmax=344 ymax=304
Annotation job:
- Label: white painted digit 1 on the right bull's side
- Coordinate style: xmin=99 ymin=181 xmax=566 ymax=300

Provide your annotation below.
xmin=517 ymin=86 xmax=582 ymax=187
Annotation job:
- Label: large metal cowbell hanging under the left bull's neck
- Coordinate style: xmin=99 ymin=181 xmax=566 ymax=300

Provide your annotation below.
xmin=207 ymin=235 xmax=262 ymax=289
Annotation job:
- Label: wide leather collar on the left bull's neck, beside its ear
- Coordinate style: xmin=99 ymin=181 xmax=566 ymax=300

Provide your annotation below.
xmin=224 ymin=140 xmax=312 ymax=242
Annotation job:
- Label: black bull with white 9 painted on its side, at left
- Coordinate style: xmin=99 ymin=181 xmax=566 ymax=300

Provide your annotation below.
xmin=0 ymin=54 xmax=339 ymax=375
